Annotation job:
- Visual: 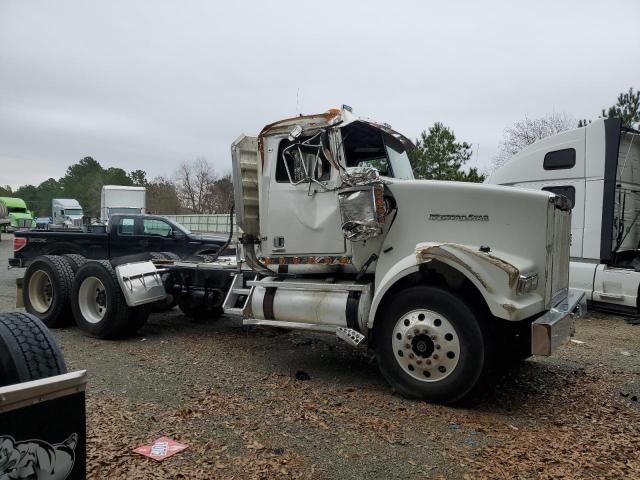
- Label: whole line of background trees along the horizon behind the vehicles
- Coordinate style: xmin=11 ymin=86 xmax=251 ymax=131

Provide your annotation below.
xmin=0 ymin=88 xmax=640 ymax=217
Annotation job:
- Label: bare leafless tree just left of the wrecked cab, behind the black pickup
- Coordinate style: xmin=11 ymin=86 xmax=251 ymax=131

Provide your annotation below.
xmin=176 ymin=157 xmax=218 ymax=213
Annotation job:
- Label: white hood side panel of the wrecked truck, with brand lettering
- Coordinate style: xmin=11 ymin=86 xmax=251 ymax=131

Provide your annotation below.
xmin=388 ymin=180 xmax=552 ymax=257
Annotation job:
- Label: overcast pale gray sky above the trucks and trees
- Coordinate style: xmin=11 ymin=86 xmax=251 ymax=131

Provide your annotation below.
xmin=0 ymin=0 xmax=640 ymax=186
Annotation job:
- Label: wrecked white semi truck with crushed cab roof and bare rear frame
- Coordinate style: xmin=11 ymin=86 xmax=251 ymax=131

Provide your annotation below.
xmin=21 ymin=107 xmax=584 ymax=402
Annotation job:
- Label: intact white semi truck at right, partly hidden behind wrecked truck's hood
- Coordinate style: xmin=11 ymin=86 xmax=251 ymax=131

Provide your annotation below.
xmin=487 ymin=118 xmax=640 ymax=316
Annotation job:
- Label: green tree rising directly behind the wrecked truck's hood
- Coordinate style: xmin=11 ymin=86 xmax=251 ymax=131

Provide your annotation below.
xmin=409 ymin=122 xmax=484 ymax=182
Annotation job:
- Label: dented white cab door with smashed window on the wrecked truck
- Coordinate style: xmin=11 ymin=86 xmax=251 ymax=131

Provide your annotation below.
xmin=261 ymin=133 xmax=345 ymax=256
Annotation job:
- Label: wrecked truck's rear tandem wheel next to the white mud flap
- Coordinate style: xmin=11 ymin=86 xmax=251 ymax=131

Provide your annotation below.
xmin=71 ymin=260 xmax=149 ymax=339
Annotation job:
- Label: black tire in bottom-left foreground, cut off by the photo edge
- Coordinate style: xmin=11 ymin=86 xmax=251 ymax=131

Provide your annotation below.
xmin=0 ymin=312 xmax=67 ymax=387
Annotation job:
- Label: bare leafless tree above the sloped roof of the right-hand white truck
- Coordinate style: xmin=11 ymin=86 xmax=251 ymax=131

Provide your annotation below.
xmin=491 ymin=113 xmax=576 ymax=170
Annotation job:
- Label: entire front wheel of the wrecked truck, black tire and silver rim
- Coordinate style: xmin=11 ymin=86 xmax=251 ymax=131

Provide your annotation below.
xmin=374 ymin=286 xmax=491 ymax=404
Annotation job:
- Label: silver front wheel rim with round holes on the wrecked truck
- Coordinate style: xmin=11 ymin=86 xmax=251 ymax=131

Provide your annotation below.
xmin=392 ymin=309 xmax=460 ymax=382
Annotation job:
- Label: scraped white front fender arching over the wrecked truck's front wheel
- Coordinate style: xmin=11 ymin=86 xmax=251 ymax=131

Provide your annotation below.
xmin=368 ymin=242 xmax=544 ymax=328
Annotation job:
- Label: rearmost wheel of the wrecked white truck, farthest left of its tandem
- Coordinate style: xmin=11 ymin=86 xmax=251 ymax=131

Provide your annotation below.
xmin=22 ymin=255 xmax=73 ymax=328
